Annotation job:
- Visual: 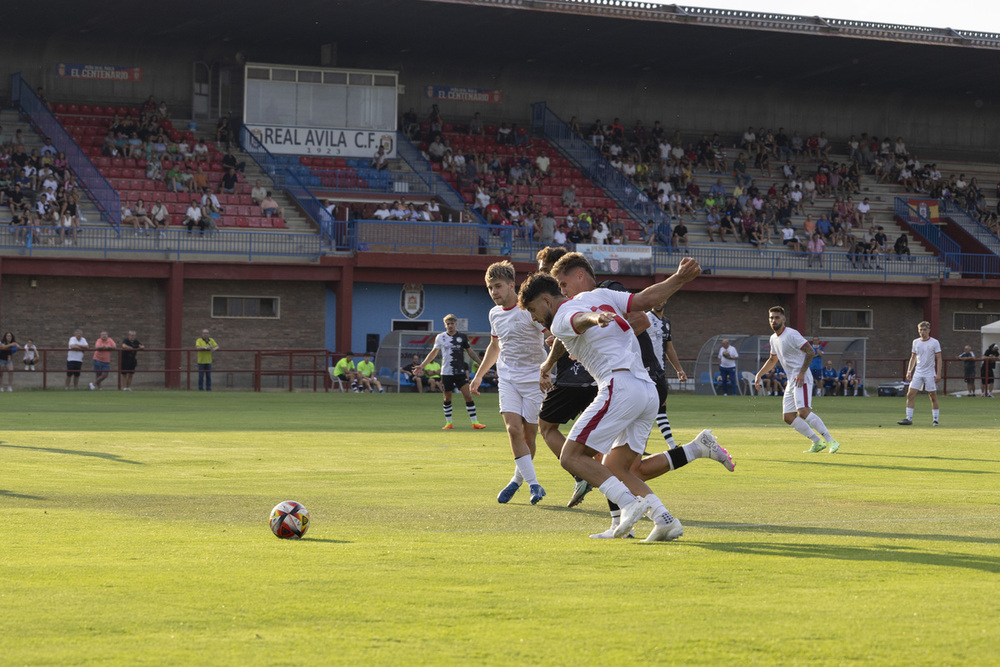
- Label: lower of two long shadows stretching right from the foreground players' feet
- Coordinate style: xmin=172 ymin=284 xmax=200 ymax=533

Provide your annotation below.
xmin=692 ymin=542 xmax=1000 ymax=574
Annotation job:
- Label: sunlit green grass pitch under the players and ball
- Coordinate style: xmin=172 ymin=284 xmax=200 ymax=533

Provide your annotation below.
xmin=0 ymin=391 xmax=1000 ymax=666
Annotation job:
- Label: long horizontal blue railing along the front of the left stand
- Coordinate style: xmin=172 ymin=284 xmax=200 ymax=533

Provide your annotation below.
xmin=0 ymin=226 xmax=323 ymax=261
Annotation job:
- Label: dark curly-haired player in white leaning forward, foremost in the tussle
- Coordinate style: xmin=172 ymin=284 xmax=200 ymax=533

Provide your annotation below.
xmin=518 ymin=257 xmax=701 ymax=542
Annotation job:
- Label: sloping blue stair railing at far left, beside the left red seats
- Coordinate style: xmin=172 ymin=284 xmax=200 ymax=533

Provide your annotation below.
xmin=10 ymin=72 xmax=122 ymax=229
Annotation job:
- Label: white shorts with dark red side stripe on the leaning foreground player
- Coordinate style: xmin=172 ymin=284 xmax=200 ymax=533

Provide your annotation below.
xmin=567 ymin=371 xmax=660 ymax=454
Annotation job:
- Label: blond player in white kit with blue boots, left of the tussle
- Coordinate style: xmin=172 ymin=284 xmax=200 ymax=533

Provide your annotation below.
xmin=471 ymin=260 xmax=546 ymax=505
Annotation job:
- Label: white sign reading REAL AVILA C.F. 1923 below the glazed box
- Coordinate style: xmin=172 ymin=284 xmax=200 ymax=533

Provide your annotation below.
xmin=246 ymin=123 xmax=396 ymax=158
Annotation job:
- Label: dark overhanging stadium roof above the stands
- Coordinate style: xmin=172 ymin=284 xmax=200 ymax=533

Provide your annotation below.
xmin=13 ymin=0 xmax=1000 ymax=101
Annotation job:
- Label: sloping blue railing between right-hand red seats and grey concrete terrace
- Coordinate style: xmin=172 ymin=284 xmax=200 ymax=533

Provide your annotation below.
xmin=531 ymin=102 xmax=670 ymax=238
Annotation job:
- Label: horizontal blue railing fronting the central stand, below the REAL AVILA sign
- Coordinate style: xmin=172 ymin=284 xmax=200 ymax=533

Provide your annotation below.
xmin=352 ymin=220 xmax=535 ymax=258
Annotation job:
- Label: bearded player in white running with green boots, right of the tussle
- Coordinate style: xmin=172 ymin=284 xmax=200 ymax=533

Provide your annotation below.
xmin=754 ymin=306 xmax=840 ymax=454
